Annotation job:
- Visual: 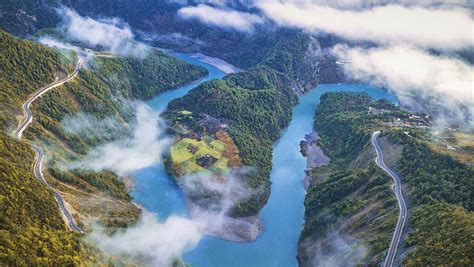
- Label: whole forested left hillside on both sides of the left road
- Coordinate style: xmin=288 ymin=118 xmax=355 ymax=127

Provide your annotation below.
xmin=0 ymin=28 xmax=206 ymax=266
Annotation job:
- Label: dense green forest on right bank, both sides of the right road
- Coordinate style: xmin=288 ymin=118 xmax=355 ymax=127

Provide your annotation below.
xmin=298 ymin=93 xmax=474 ymax=266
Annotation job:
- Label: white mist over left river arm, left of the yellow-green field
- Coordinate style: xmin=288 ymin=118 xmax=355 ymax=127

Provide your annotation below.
xmin=77 ymin=103 xmax=171 ymax=176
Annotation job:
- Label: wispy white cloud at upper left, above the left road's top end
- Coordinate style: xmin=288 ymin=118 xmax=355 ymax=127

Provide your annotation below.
xmin=57 ymin=7 xmax=147 ymax=57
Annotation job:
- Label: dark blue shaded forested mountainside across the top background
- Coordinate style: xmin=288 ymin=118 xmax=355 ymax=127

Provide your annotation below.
xmin=0 ymin=0 xmax=344 ymax=83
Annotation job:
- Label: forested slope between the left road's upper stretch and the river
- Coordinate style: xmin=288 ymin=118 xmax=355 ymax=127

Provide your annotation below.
xmin=27 ymin=48 xmax=206 ymax=154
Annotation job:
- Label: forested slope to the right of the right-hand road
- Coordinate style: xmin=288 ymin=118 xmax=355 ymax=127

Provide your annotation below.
xmin=389 ymin=132 xmax=474 ymax=266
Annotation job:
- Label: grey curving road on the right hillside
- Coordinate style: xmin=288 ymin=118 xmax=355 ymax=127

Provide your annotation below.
xmin=372 ymin=131 xmax=407 ymax=267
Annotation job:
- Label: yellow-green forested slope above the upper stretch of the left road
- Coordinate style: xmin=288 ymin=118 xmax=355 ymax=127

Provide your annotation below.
xmin=0 ymin=30 xmax=75 ymax=131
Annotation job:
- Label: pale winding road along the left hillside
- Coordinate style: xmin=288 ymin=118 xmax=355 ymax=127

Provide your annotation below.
xmin=15 ymin=58 xmax=82 ymax=232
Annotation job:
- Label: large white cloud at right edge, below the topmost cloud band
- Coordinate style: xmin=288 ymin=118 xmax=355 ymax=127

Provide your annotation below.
xmin=333 ymin=45 xmax=474 ymax=125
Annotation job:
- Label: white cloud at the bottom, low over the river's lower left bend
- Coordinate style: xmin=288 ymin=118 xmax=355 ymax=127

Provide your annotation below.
xmin=89 ymin=212 xmax=202 ymax=266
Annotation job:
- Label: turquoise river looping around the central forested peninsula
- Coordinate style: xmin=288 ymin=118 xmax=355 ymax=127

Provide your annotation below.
xmin=132 ymin=54 xmax=396 ymax=267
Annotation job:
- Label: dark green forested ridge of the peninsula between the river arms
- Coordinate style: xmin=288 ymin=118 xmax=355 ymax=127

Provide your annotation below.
xmin=168 ymin=32 xmax=318 ymax=216
